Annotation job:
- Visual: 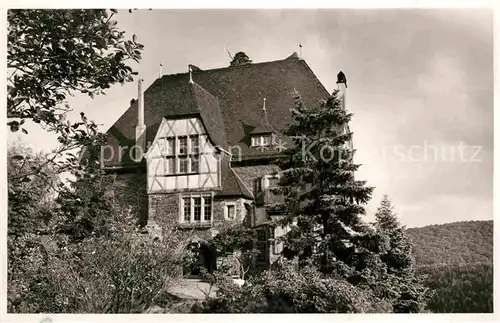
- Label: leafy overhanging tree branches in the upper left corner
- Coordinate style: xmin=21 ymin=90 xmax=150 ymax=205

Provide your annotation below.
xmin=7 ymin=9 xmax=143 ymax=179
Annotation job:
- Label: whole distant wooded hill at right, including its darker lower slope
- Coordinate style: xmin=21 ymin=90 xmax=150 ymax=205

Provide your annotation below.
xmin=408 ymin=221 xmax=493 ymax=313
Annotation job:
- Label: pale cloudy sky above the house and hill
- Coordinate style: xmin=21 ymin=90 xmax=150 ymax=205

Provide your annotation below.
xmin=8 ymin=9 xmax=493 ymax=227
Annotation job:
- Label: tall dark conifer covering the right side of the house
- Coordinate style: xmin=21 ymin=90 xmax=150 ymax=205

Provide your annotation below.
xmin=275 ymin=91 xmax=390 ymax=289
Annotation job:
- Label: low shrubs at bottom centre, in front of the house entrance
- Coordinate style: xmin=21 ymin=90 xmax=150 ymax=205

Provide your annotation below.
xmin=192 ymin=262 xmax=391 ymax=313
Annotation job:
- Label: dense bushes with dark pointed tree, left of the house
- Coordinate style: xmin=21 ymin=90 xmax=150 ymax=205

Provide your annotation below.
xmin=8 ymin=143 xmax=193 ymax=313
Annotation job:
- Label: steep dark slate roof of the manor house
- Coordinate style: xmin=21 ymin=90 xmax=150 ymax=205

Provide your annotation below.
xmin=107 ymin=55 xmax=329 ymax=165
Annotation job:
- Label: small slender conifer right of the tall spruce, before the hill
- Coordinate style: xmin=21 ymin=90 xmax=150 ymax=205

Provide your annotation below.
xmin=375 ymin=195 xmax=430 ymax=313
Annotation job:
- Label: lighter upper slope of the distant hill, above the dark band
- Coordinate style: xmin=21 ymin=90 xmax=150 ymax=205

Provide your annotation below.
xmin=407 ymin=221 xmax=493 ymax=266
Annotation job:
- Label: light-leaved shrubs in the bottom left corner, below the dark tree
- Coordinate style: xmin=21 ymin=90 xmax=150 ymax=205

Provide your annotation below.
xmin=8 ymin=218 xmax=195 ymax=313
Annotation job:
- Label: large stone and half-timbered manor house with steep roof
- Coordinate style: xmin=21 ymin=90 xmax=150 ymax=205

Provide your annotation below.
xmin=102 ymin=53 xmax=346 ymax=278
